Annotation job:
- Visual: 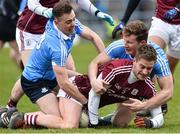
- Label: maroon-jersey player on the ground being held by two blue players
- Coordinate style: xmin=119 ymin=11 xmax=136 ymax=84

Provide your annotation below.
xmin=6 ymin=45 xmax=164 ymax=128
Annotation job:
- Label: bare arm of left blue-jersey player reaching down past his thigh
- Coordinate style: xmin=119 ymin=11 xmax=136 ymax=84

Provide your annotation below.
xmin=53 ymin=65 xmax=87 ymax=104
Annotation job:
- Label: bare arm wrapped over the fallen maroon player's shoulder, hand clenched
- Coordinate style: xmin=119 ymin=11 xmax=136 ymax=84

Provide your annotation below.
xmin=88 ymin=51 xmax=111 ymax=94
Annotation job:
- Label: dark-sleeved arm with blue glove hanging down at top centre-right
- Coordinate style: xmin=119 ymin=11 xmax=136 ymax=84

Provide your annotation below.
xmin=112 ymin=0 xmax=140 ymax=39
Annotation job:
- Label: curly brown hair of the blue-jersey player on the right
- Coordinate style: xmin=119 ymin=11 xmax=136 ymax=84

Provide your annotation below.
xmin=123 ymin=20 xmax=148 ymax=42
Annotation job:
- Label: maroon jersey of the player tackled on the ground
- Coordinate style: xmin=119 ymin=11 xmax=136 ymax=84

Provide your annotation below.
xmin=74 ymin=59 xmax=156 ymax=107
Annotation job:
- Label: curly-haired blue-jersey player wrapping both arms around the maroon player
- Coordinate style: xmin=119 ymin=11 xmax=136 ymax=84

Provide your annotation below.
xmin=89 ymin=21 xmax=173 ymax=126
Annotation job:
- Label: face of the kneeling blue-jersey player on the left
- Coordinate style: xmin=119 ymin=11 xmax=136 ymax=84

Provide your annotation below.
xmin=55 ymin=10 xmax=75 ymax=36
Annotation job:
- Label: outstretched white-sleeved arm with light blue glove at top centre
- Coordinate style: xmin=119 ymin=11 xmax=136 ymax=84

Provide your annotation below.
xmin=74 ymin=0 xmax=114 ymax=26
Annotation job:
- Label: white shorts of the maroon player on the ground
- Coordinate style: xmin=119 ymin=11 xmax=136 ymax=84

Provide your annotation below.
xmin=57 ymin=76 xmax=82 ymax=106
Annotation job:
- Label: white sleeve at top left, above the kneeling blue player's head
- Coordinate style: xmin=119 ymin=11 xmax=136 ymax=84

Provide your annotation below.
xmin=27 ymin=0 xmax=48 ymax=15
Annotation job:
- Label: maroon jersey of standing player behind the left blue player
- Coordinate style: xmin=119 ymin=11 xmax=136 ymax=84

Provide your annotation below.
xmin=17 ymin=0 xmax=59 ymax=34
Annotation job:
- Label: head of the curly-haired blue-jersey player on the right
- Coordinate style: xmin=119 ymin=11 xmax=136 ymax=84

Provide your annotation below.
xmin=123 ymin=20 xmax=148 ymax=56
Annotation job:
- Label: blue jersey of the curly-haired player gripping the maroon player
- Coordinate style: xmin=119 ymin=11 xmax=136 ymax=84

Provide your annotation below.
xmin=106 ymin=40 xmax=171 ymax=78
